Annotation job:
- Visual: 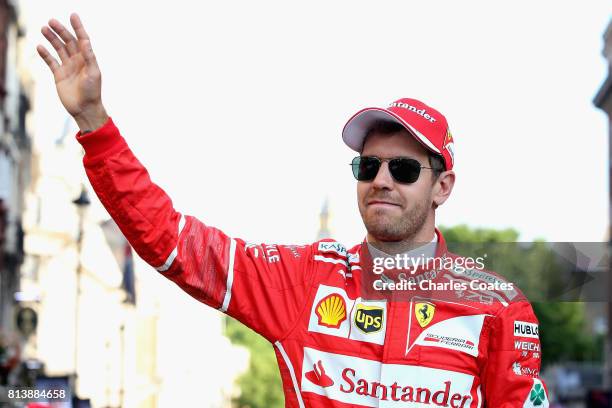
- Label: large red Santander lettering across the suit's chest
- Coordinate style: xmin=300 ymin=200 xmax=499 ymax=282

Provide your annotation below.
xmin=339 ymin=367 xmax=472 ymax=408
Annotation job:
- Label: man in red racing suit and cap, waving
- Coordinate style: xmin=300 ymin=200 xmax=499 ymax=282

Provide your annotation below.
xmin=37 ymin=14 xmax=548 ymax=408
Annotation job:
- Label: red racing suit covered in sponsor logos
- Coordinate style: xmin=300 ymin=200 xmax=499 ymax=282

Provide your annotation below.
xmin=77 ymin=119 xmax=548 ymax=408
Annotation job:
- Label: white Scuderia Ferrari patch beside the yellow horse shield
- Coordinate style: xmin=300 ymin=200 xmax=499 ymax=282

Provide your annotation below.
xmin=415 ymin=314 xmax=487 ymax=357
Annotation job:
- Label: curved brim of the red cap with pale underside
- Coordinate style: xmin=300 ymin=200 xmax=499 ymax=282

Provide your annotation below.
xmin=342 ymin=108 xmax=441 ymax=154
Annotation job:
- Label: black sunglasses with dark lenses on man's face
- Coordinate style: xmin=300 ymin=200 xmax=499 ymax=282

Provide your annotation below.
xmin=351 ymin=156 xmax=432 ymax=184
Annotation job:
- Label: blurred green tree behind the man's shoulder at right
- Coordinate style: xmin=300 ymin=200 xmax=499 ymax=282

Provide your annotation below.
xmin=440 ymin=225 xmax=604 ymax=366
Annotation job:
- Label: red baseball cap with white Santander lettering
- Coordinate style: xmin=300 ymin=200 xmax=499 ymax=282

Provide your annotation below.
xmin=342 ymin=98 xmax=455 ymax=170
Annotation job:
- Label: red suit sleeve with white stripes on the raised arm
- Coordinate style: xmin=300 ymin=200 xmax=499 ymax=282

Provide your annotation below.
xmin=76 ymin=119 xmax=312 ymax=341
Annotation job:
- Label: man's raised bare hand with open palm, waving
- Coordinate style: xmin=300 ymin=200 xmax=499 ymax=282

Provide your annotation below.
xmin=36 ymin=13 xmax=108 ymax=131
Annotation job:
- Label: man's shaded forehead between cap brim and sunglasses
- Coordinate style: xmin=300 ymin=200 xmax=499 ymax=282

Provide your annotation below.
xmin=361 ymin=129 xmax=428 ymax=159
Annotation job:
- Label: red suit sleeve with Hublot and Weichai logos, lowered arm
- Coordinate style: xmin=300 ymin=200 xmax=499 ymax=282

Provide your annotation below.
xmin=482 ymin=301 xmax=549 ymax=408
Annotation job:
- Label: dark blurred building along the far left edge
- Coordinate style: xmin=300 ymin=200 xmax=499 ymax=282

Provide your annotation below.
xmin=0 ymin=0 xmax=30 ymax=383
